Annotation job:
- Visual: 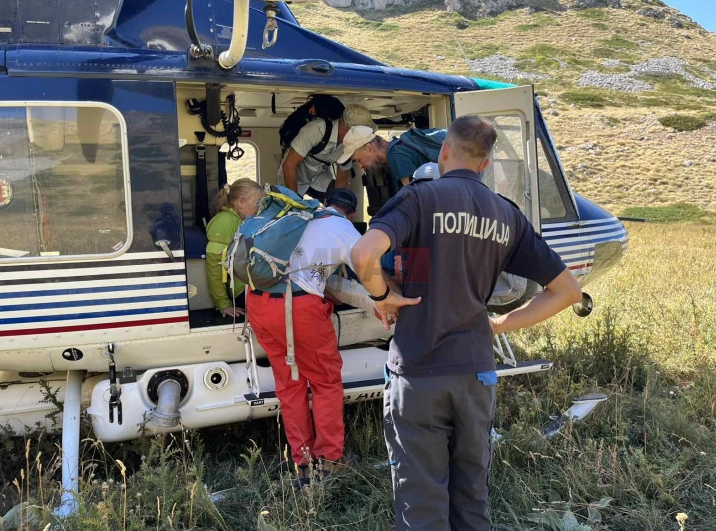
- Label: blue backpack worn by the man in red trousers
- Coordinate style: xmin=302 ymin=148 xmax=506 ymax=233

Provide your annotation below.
xmin=226 ymin=185 xmax=340 ymax=293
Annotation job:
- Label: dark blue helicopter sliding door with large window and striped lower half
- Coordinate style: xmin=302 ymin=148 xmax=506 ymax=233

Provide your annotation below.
xmin=0 ymin=77 xmax=188 ymax=358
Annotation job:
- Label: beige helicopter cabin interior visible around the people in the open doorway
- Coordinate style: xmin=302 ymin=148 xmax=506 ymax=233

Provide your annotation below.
xmin=176 ymin=83 xmax=449 ymax=330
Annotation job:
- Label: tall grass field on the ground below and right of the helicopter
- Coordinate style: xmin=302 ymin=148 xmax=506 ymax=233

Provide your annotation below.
xmin=5 ymin=219 xmax=716 ymax=531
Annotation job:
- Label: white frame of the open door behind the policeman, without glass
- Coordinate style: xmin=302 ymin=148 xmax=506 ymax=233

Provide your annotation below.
xmin=453 ymin=85 xmax=540 ymax=233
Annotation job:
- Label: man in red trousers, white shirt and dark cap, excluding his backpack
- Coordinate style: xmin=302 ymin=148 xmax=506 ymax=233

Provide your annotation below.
xmin=247 ymin=189 xmax=360 ymax=485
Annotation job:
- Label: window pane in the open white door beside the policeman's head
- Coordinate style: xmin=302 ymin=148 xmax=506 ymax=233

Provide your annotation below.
xmin=482 ymin=116 xmax=526 ymax=212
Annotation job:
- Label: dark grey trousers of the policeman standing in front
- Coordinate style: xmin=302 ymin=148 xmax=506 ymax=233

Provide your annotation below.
xmin=383 ymin=373 xmax=496 ymax=531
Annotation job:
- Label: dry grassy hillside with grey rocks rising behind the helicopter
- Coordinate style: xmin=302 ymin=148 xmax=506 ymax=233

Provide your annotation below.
xmin=292 ymin=0 xmax=716 ymax=212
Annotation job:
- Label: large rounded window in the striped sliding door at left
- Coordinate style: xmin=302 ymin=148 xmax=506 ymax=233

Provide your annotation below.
xmin=0 ymin=102 xmax=130 ymax=260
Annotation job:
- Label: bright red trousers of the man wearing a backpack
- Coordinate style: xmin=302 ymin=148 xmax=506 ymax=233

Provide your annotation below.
xmin=247 ymin=293 xmax=344 ymax=465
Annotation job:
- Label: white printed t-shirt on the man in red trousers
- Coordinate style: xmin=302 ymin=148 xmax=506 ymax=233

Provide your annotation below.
xmin=289 ymin=209 xmax=360 ymax=297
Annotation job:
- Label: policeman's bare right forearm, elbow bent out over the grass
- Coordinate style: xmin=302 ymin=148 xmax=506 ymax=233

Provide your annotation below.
xmin=494 ymin=269 xmax=582 ymax=334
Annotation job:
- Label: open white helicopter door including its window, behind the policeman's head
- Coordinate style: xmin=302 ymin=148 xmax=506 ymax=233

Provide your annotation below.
xmin=454 ymin=86 xmax=540 ymax=232
